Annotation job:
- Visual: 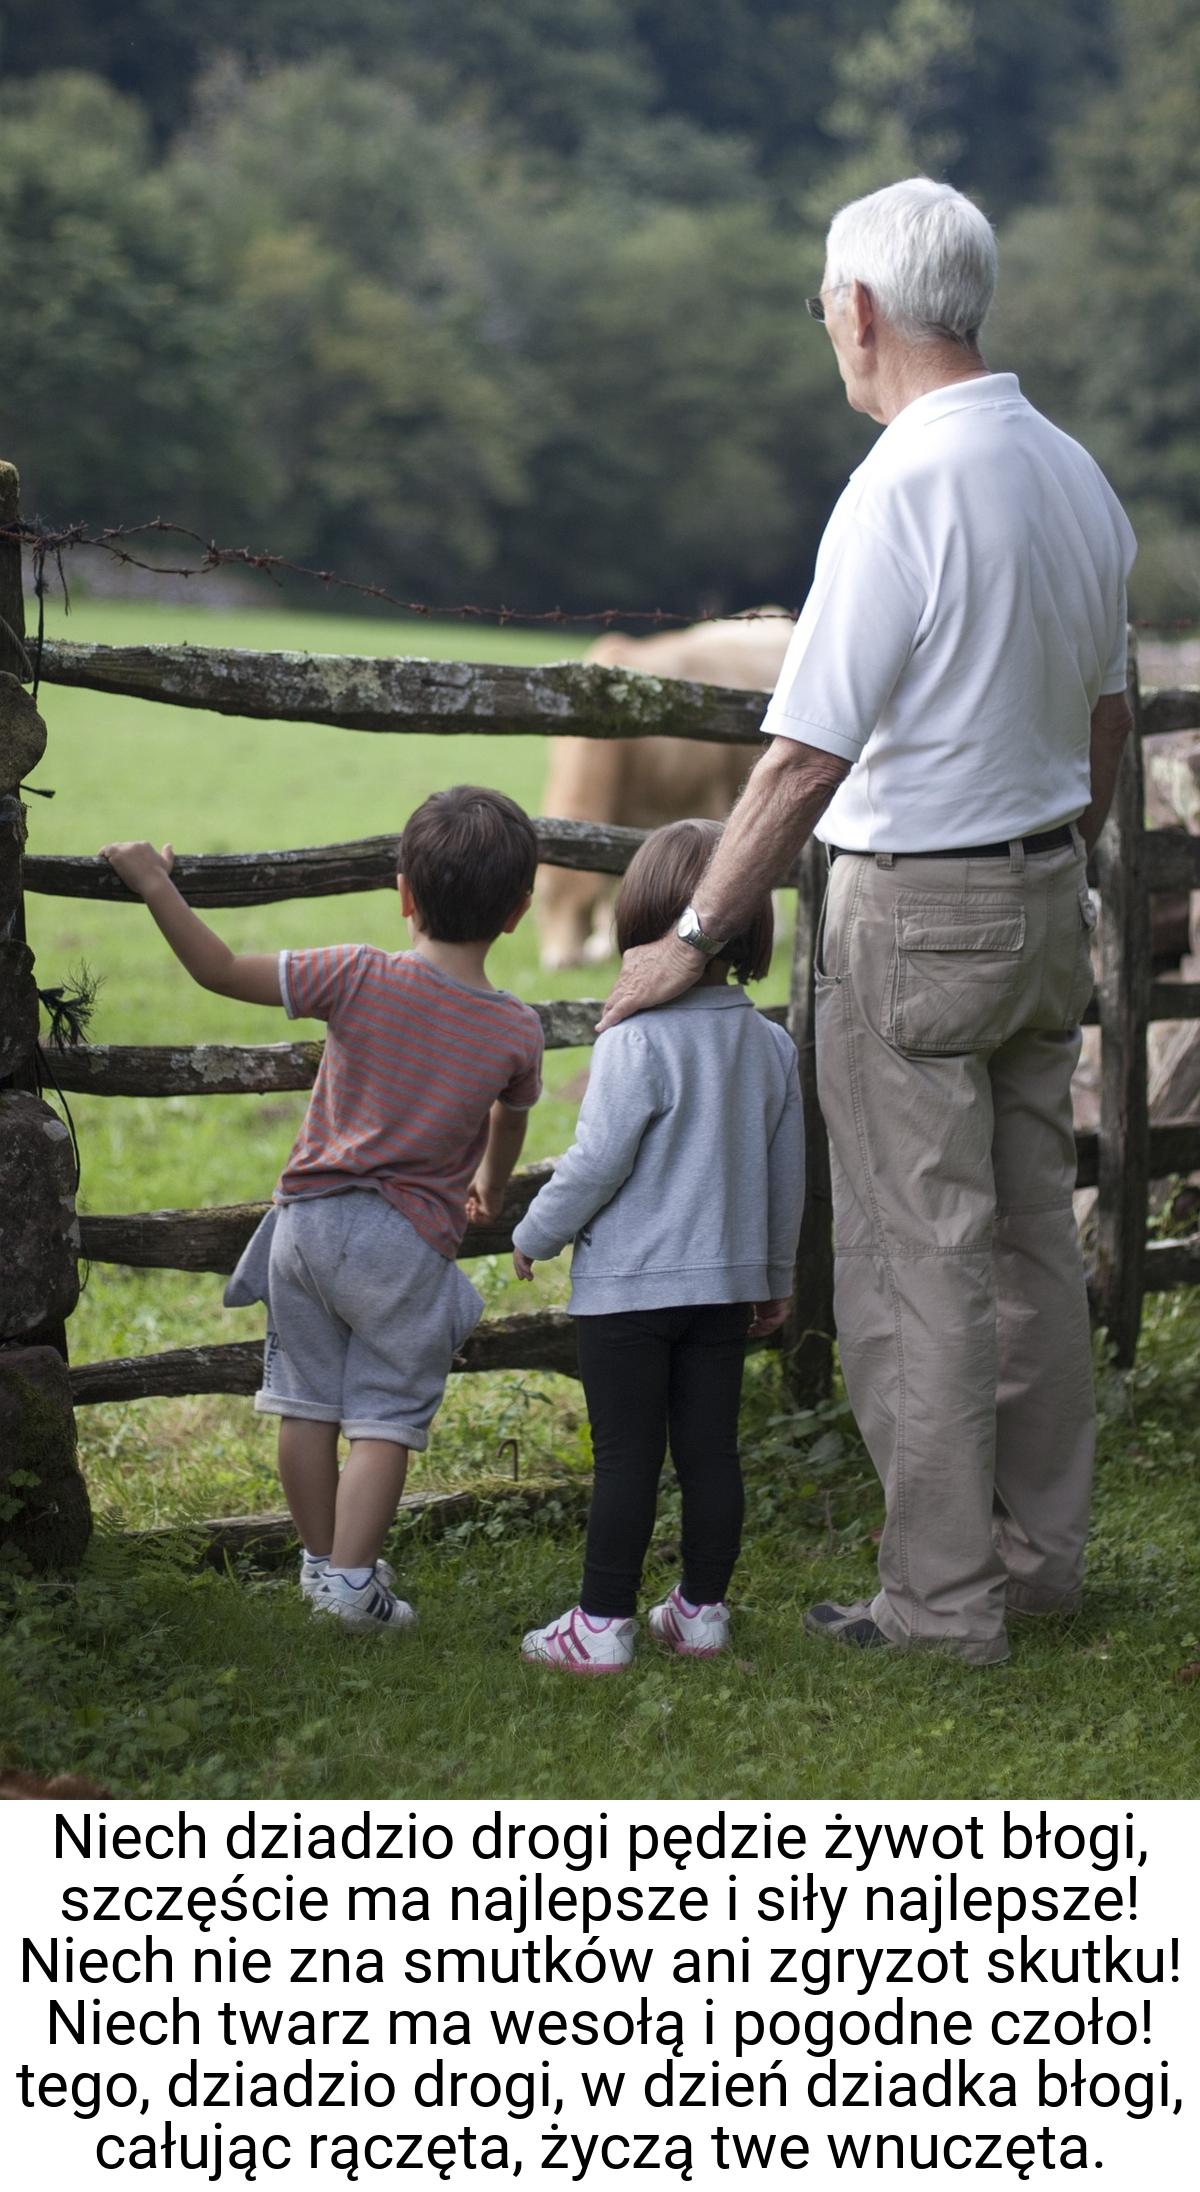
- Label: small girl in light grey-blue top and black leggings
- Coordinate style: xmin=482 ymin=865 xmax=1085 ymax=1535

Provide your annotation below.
xmin=513 ymin=822 xmax=805 ymax=1675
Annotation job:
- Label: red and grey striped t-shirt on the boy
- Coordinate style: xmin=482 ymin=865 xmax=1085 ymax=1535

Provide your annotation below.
xmin=274 ymin=945 xmax=542 ymax=1256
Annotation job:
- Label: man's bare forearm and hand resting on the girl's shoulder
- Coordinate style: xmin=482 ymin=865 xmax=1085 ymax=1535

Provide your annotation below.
xmin=599 ymin=739 xmax=849 ymax=1035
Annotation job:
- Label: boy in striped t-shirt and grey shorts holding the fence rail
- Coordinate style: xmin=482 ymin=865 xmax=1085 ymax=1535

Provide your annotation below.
xmin=103 ymin=785 xmax=542 ymax=1635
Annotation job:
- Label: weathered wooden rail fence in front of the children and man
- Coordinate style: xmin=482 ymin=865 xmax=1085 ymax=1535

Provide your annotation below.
xmin=7 ymin=600 xmax=1200 ymax=1403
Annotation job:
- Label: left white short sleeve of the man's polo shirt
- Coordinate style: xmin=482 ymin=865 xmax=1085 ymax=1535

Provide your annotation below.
xmin=763 ymin=509 xmax=926 ymax=763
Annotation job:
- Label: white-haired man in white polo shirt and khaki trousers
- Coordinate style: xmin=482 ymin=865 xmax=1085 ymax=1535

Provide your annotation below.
xmin=601 ymin=178 xmax=1134 ymax=1666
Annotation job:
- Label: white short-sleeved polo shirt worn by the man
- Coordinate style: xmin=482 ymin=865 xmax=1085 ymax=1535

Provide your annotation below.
xmin=763 ymin=373 xmax=1136 ymax=853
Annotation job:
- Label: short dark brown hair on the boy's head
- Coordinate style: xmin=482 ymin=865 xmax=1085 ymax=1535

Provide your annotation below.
xmin=399 ymin=785 xmax=537 ymax=945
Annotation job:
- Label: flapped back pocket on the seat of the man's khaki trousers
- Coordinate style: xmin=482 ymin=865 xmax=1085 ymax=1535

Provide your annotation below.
xmin=882 ymin=901 xmax=1027 ymax=1057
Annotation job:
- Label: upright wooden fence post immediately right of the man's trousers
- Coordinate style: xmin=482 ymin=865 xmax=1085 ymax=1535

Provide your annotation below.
xmin=1095 ymin=631 xmax=1152 ymax=1368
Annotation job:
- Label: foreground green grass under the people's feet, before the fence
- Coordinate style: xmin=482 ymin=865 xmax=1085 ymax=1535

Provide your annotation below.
xmin=0 ymin=1302 xmax=1200 ymax=1800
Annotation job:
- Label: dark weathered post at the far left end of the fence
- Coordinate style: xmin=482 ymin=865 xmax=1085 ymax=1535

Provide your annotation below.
xmin=0 ymin=465 xmax=92 ymax=1569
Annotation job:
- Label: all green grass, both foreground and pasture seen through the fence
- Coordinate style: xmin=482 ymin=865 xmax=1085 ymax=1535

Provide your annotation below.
xmin=9 ymin=603 xmax=1200 ymax=1797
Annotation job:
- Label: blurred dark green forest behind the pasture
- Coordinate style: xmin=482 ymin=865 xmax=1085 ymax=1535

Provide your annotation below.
xmin=0 ymin=0 xmax=1200 ymax=618
